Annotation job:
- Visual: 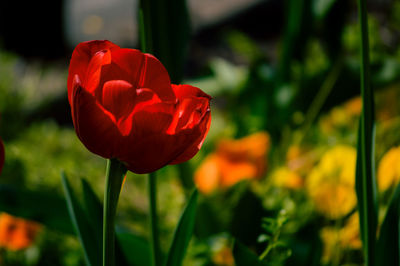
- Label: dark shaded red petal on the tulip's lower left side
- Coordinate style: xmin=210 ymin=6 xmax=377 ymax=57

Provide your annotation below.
xmin=71 ymin=82 xmax=121 ymax=158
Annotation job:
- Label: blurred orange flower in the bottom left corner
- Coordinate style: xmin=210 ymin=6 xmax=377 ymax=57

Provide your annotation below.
xmin=0 ymin=213 xmax=41 ymax=251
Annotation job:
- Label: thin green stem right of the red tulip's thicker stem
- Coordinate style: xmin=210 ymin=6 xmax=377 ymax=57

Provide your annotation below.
xmin=148 ymin=172 xmax=161 ymax=266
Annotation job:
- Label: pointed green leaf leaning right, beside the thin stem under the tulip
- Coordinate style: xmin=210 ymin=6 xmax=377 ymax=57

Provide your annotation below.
xmin=165 ymin=189 xmax=198 ymax=266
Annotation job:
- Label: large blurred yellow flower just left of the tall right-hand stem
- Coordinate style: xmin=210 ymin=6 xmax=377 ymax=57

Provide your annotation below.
xmin=306 ymin=145 xmax=357 ymax=219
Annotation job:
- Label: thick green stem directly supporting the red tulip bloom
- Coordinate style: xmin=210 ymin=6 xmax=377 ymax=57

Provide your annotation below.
xmin=103 ymin=159 xmax=127 ymax=266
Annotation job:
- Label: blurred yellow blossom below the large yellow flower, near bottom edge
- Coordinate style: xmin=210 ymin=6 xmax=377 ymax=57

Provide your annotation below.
xmin=320 ymin=213 xmax=362 ymax=262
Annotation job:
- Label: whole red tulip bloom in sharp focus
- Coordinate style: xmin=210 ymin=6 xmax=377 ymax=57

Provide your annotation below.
xmin=68 ymin=41 xmax=211 ymax=173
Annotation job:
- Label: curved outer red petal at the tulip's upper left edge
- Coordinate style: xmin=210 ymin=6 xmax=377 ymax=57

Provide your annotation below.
xmin=67 ymin=41 xmax=119 ymax=103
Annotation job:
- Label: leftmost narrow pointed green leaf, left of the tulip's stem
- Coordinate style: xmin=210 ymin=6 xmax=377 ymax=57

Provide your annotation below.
xmin=61 ymin=173 xmax=102 ymax=266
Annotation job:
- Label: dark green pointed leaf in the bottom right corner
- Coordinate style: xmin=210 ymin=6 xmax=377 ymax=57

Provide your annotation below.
xmin=376 ymin=184 xmax=400 ymax=266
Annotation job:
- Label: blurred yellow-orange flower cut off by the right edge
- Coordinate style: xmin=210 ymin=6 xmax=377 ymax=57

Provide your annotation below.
xmin=377 ymin=146 xmax=400 ymax=191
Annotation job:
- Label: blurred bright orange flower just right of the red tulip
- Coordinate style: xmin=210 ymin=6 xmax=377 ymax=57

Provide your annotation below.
xmin=194 ymin=132 xmax=270 ymax=193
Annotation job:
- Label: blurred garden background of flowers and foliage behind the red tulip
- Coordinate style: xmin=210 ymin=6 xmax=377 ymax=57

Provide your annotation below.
xmin=0 ymin=0 xmax=400 ymax=265
